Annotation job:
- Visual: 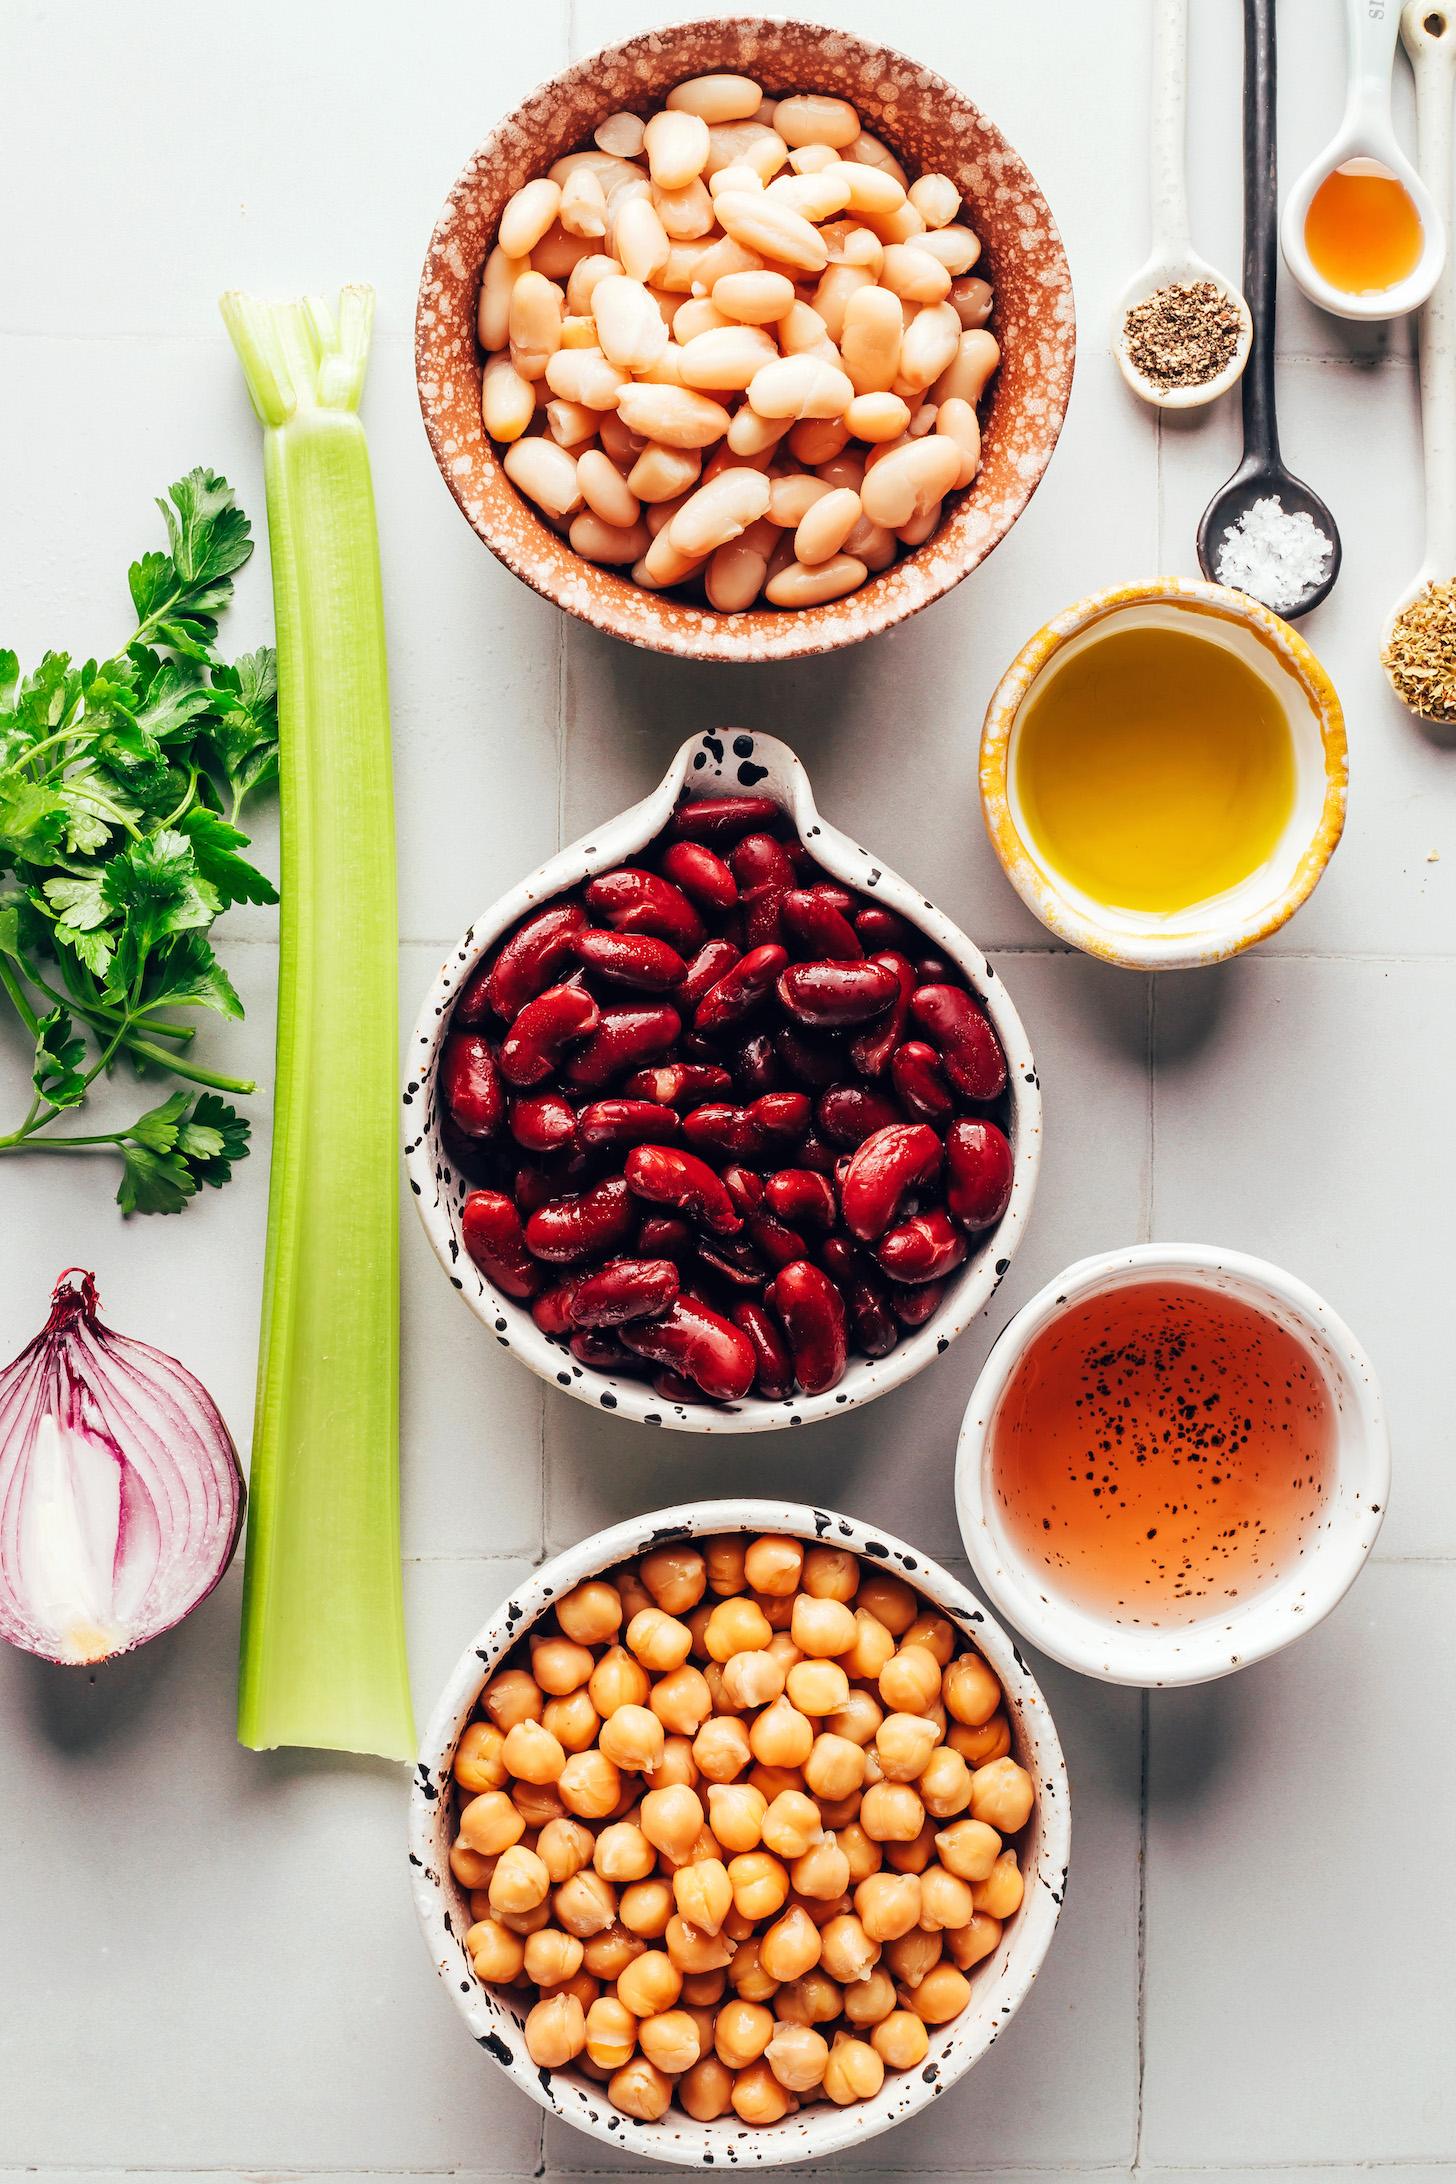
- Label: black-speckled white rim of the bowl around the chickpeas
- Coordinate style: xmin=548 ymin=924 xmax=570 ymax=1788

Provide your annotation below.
xmin=408 ymin=1496 xmax=1072 ymax=2169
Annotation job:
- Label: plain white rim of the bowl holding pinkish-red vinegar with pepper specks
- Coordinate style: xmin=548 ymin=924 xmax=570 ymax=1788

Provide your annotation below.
xmin=956 ymin=1243 xmax=1391 ymax=1690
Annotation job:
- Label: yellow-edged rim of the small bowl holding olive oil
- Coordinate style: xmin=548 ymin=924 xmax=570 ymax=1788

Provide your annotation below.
xmin=980 ymin=577 xmax=1349 ymax=970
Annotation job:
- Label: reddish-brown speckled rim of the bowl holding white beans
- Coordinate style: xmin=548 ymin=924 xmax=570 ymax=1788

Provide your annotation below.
xmin=415 ymin=15 xmax=1076 ymax=662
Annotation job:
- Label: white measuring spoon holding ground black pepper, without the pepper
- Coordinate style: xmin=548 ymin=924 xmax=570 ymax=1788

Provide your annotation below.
xmin=1113 ymin=0 xmax=1253 ymax=408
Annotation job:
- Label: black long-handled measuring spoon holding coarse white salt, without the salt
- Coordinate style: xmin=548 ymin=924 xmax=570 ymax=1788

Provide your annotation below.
xmin=1198 ymin=0 xmax=1340 ymax=622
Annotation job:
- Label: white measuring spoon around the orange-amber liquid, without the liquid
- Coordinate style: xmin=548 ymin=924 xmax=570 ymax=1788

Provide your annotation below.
xmin=1279 ymin=0 xmax=1445 ymax=321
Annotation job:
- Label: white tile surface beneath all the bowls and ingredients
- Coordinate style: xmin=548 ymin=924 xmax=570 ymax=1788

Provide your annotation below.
xmin=0 ymin=0 xmax=1456 ymax=2184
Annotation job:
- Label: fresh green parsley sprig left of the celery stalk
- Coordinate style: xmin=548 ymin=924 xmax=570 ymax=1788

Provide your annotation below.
xmin=0 ymin=470 xmax=277 ymax=1214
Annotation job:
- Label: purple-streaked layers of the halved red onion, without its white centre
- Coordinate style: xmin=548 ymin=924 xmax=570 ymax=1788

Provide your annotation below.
xmin=0 ymin=1267 xmax=247 ymax=1666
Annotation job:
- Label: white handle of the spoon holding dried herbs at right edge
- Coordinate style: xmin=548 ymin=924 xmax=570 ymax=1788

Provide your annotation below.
xmin=1380 ymin=0 xmax=1456 ymax=698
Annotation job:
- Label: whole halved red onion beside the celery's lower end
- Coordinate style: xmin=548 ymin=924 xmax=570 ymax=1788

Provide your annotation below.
xmin=0 ymin=1267 xmax=244 ymax=1662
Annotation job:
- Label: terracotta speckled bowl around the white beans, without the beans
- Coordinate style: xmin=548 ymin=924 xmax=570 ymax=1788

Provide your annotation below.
xmin=415 ymin=15 xmax=1076 ymax=660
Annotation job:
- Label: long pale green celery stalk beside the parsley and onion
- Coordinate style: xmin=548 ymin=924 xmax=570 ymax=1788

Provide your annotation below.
xmin=223 ymin=288 xmax=415 ymax=1760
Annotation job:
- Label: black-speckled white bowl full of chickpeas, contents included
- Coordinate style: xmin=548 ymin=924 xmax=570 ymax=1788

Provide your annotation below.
xmin=410 ymin=1500 xmax=1070 ymax=2167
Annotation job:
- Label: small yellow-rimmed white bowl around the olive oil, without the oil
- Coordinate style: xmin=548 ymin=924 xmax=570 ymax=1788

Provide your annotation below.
xmin=980 ymin=577 xmax=1349 ymax=970
